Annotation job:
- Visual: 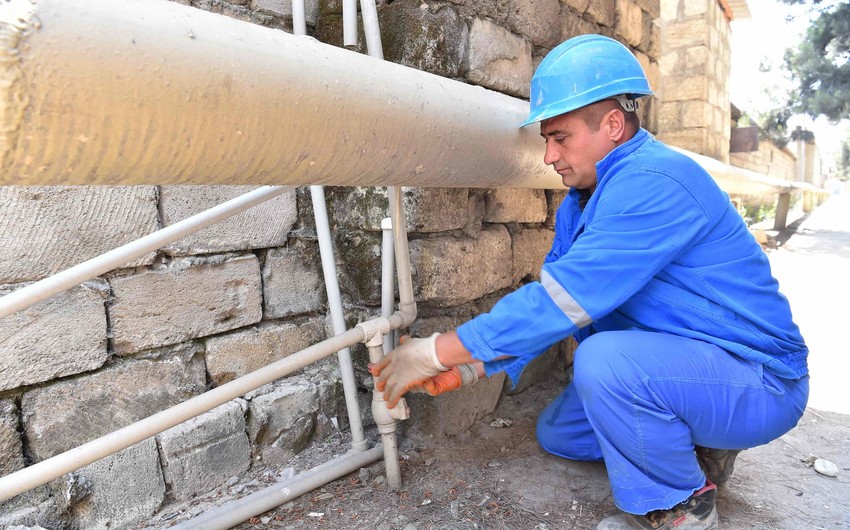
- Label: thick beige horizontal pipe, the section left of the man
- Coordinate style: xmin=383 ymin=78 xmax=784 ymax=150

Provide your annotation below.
xmin=0 ymin=0 xmax=562 ymax=188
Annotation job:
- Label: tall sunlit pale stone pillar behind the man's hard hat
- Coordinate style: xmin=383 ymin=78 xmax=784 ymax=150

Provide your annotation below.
xmin=658 ymin=0 xmax=731 ymax=163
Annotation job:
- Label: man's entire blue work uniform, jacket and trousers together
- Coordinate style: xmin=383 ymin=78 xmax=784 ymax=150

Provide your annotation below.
xmin=457 ymin=129 xmax=808 ymax=513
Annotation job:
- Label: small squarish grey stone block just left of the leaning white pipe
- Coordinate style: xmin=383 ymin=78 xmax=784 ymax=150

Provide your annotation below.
xmin=263 ymin=240 xmax=324 ymax=319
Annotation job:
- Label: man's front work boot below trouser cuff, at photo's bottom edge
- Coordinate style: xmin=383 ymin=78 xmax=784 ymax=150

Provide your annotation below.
xmin=596 ymin=482 xmax=717 ymax=530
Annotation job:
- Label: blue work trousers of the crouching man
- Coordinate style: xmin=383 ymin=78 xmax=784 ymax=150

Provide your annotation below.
xmin=537 ymin=331 xmax=809 ymax=514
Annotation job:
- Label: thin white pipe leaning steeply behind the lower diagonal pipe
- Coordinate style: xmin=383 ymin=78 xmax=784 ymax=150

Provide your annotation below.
xmin=310 ymin=186 xmax=366 ymax=451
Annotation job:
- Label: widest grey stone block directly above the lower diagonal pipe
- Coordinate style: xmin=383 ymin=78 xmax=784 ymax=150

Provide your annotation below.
xmin=21 ymin=346 xmax=206 ymax=461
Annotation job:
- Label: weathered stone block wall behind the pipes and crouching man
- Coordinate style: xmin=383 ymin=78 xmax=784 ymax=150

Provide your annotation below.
xmin=0 ymin=0 xmax=660 ymax=529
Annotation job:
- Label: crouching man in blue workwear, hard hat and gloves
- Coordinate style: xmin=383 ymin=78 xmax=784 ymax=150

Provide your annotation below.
xmin=371 ymin=35 xmax=809 ymax=530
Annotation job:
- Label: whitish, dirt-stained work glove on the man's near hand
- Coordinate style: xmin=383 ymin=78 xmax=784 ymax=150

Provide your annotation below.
xmin=369 ymin=333 xmax=448 ymax=408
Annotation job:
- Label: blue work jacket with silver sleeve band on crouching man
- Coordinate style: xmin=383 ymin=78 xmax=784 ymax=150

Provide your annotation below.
xmin=457 ymin=129 xmax=808 ymax=384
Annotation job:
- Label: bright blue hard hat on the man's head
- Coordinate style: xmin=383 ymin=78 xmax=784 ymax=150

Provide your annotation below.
xmin=520 ymin=35 xmax=652 ymax=127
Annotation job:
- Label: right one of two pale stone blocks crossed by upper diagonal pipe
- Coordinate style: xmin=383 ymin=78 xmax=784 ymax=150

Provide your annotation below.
xmin=159 ymin=186 xmax=298 ymax=255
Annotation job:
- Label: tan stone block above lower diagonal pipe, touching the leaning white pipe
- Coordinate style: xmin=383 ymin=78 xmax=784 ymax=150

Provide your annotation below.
xmin=206 ymin=318 xmax=327 ymax=385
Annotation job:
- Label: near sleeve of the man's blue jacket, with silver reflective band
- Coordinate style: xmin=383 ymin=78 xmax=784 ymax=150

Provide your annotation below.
xmin=457 ymin=171 xmax=709 ymax=384
